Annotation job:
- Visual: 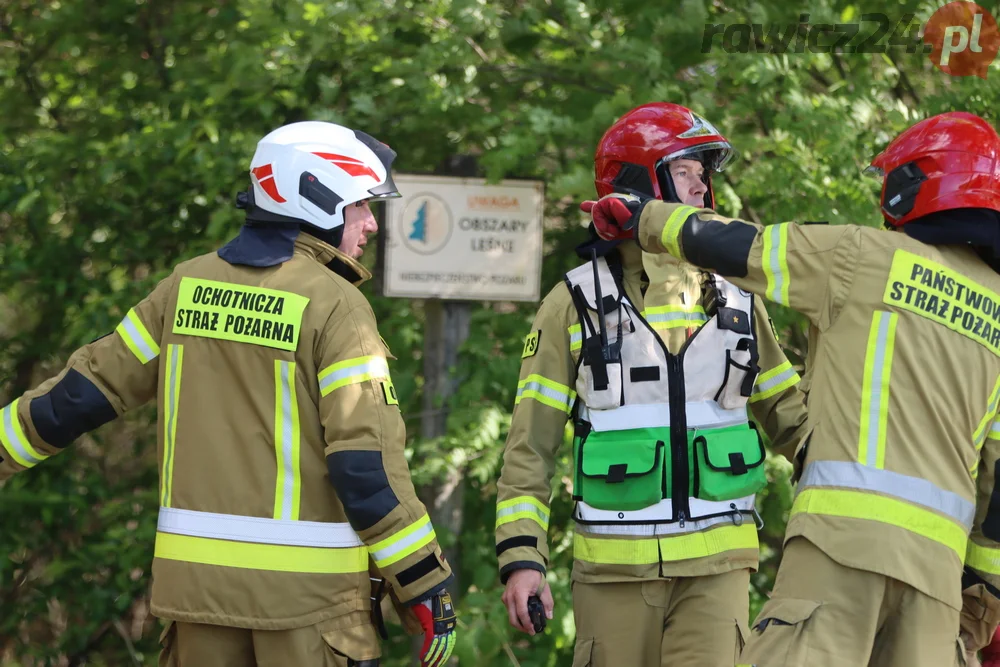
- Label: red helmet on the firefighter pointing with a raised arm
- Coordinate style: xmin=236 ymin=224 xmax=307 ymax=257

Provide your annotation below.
xmin=865 ymin=111 xmax=1000 ymax=227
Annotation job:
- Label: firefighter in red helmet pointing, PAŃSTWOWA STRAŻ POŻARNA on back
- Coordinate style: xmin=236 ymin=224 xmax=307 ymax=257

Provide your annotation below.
xmin=585 ymin=113 xmax=1000 ymax=667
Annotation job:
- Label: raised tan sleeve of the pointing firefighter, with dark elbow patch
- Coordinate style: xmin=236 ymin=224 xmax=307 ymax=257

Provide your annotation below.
xmin=639 ymin=200 xmax=860 ymax=329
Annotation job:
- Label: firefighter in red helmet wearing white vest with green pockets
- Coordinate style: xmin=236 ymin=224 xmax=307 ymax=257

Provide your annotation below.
xmin=496 ymin=103 xmax=805 ymax=667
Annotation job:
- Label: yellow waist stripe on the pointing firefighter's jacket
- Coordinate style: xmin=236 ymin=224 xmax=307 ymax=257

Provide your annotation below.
xmin=791 ymin=489 xmax=967 ymax=560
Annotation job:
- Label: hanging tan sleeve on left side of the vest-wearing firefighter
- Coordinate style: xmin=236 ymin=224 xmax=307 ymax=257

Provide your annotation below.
xmin=496 ymin=285 xmax=576 ymax=583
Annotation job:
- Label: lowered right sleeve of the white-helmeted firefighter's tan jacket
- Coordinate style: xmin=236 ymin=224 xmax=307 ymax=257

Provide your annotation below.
xmin=318 ymin=288 xmax=451 ymax=604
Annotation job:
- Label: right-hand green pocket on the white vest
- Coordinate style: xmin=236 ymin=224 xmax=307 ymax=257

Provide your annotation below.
xmin=688 ymin=424 xmax=767 ymax=501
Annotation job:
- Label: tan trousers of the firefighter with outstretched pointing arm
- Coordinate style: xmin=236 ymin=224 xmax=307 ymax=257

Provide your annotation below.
xmin=741 ymin=537 xmax=965 ymax=667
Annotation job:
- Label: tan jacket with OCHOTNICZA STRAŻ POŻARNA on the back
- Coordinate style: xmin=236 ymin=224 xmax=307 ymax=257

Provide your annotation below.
xmin=0 ymin=233 xmax=450 ymax=632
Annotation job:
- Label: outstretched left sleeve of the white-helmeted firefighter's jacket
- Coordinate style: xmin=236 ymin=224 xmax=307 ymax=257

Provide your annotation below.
xmin=0 ymin=276 xmax=173 ymax=481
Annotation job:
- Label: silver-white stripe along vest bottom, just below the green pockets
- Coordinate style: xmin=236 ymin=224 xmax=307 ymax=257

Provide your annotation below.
xmin=573 ymin=495 xmax=755 ymax=537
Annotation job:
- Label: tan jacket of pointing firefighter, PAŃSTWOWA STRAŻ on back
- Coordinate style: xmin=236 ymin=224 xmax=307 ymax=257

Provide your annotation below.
xmin=639 ymin=202 xmax=1000 ymax=608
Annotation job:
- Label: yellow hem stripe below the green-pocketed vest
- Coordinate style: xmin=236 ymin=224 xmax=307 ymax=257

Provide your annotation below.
xmin=573 ymin=523 xmax=759 ymax=565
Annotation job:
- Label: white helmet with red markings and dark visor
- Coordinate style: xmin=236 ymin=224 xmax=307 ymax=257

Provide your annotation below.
xmin=250 ymin=121 xmax=400 ymax=230
